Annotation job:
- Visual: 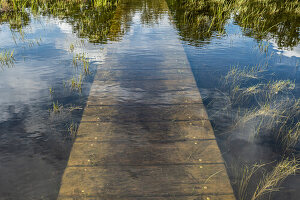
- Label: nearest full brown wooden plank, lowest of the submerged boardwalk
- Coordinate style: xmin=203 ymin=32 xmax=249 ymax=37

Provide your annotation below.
xmin=57 ymin=165 xmax=233 ymax=199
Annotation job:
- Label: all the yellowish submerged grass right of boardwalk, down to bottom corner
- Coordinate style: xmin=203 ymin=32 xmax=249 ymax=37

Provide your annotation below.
xmin=222 ymin=61 xmax=300 ymax=200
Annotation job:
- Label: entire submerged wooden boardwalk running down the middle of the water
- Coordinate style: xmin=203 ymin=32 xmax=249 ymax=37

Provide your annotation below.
xmin=58 ymin=0 xmax=235 ymax=200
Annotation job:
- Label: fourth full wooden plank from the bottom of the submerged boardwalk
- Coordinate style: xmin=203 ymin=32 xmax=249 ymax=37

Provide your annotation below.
xmin=82 ymin=104 xmax=208 ymax=123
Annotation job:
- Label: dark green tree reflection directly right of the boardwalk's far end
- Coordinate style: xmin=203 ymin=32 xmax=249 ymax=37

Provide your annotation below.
xmin=167 ymin=0 xmax=232 ymax=46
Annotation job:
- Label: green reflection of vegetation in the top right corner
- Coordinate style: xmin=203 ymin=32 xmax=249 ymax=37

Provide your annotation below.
xmin=235 ymin=0 xmax=300 ymax=48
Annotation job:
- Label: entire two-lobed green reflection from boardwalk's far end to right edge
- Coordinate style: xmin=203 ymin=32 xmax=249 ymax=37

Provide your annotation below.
xmin=167 ymin=0 xmax=300 ymax=48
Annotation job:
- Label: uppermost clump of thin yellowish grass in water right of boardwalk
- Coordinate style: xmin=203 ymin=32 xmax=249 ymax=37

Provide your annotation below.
xmin=223 ymin=65 xmax=295 ymax=106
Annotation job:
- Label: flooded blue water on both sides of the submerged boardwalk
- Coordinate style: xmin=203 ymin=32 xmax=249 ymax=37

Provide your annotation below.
xmin=0 ymin=0 xmax=300 ymax=200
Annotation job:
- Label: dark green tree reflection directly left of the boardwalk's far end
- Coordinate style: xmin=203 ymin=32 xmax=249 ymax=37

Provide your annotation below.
xmin=37 ymin=1 xmax=120 ymax=43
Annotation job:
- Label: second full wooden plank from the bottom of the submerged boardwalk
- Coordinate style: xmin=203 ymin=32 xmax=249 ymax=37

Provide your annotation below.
xmin=63 ymin=140 xmax=223 ymax=166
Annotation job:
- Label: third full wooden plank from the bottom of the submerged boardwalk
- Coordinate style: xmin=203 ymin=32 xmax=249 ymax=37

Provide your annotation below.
xmin=76 ymin=120 xmax=215 ymax=142
